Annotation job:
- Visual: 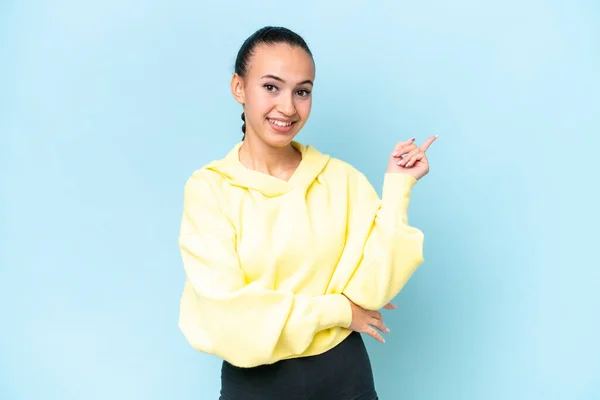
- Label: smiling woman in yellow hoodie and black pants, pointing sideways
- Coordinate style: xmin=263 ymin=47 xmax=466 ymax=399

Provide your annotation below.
xmin=179 ymin=27 xmax=436 ymax=400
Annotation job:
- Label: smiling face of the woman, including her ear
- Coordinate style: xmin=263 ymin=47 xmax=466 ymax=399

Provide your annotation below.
xmin=231 ymin=44 xmax=315 ymax=147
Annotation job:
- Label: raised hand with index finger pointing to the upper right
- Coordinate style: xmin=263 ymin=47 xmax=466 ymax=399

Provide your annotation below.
xmin=387 ymin=135 xmax=437 ymax=180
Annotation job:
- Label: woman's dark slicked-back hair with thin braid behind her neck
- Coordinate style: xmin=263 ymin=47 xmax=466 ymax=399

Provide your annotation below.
xmin=235 ymin=26 xmax=313 ymax=140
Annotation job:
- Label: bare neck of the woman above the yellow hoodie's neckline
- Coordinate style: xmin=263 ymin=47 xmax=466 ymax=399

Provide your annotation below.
xmin=239 ymin=135 xmax=302 ymax=175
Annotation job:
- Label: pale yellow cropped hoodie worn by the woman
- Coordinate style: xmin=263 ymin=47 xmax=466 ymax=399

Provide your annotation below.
xmin=179 ymin=142 xmax=423 ymax=367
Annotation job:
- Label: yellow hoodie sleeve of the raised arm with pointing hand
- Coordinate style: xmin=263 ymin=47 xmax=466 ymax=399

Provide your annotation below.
xmin=343 ymin=171 xmax=424 ymax=310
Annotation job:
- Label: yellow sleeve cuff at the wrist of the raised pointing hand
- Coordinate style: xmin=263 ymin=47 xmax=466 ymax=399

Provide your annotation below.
xmin=380 ymin=172 xmax=417 ymax=225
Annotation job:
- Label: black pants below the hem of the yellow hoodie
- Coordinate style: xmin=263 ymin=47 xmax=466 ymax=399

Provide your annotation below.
xmin=219 ymin=332 xmax=378 ymax=400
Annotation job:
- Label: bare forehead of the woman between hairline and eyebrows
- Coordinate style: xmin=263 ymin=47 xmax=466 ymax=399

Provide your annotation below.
xmin=248 ymin=44 xmax=315 ymax=82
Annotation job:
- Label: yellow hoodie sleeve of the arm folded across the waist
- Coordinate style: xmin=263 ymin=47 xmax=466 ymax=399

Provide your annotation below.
xmin=179 ymin=170 xmax=352 ymax=367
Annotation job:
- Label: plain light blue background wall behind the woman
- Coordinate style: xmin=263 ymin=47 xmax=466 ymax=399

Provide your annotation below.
xmin=0 ymin=0 xmax=600 ymax=400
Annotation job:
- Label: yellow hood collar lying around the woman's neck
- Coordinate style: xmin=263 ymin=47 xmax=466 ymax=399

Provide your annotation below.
xmin=206 ymin=142 xmax=330 ymax=197
